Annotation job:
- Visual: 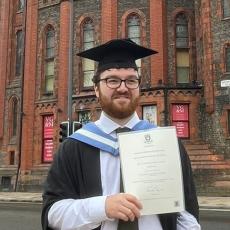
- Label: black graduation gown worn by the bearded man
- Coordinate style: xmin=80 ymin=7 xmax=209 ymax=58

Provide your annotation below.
xmin=42 ymin=139 xmax=199 ymax=230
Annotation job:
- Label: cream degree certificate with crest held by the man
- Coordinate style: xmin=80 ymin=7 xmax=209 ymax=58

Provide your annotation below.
xmin=118 ymin=126 xmax=185 ymax=215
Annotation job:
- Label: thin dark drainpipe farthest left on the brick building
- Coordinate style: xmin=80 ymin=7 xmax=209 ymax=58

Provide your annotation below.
xmin=14 ymin=0 xmax=27 ymax=192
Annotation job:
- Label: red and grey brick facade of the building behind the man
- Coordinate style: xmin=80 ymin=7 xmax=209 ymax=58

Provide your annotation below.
xmin=0 ymin=0 xmax=230 ymax=190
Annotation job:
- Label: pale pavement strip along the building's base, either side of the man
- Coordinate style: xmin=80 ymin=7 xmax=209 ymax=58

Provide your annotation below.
xmin=0 ymin=192 xmax=230 ymax=211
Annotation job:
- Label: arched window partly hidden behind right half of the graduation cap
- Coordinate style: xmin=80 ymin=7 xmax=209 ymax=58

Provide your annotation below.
xmin=127 ymin=14 xmax=141 ymax=74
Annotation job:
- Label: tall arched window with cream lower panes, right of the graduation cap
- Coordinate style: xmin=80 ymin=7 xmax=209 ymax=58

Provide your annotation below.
xmin=176 ymin=13 xmax=190 ymax=83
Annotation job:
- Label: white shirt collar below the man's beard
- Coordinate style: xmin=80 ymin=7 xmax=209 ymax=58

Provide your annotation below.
xmin=95 ymin=111 xmax=140 ymax=134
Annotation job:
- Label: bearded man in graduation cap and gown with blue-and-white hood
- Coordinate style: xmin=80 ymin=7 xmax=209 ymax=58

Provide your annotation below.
xmin=42 ymin=39 xmax=200 ymax=230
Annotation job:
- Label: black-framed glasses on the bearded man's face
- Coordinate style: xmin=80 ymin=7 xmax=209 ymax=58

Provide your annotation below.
xmin=97 ymin=77 xmax=141 ymax=89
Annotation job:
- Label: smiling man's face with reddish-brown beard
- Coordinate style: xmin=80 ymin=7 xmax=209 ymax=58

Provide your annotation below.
xmin=95 ymin=68 xmax=139 ymax=119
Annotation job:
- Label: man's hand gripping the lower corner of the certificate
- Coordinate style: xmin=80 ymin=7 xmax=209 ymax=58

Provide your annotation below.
xmin=105 ymin=193 xmax=142 ymax=221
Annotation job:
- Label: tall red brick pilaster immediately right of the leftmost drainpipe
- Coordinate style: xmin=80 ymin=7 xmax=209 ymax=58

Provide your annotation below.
xmin=21 ymin=0 xmax=38 ymax=174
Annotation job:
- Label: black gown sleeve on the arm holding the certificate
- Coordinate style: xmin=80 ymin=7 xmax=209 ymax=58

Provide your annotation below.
xmin=41 ymin=138 xmax=102 ymax=230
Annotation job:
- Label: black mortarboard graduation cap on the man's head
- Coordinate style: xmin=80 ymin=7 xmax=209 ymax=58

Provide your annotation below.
xmin=77 ymin=39 xmax=157 ymax=72
